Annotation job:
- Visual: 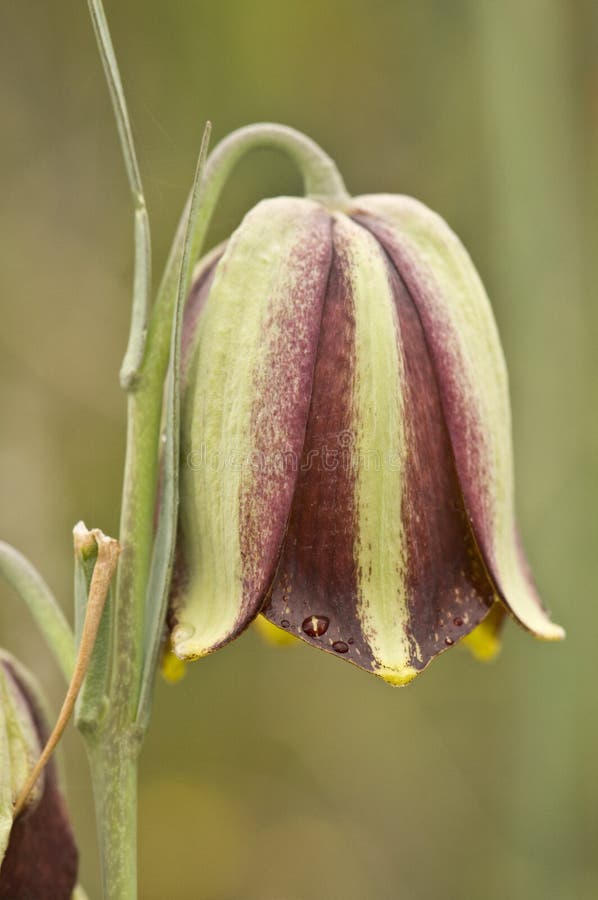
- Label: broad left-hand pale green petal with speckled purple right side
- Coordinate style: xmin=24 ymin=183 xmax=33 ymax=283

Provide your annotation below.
xmin=171 ymin=198 xmax=331 ymax=658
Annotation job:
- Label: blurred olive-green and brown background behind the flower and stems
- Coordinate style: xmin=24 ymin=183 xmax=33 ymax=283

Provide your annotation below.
xmin=0 ymin=0 xmax=598 ymax=900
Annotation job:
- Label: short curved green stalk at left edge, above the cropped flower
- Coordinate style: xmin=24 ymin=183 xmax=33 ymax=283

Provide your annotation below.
xmin=0 ymin=541 xmax=75 ymax=682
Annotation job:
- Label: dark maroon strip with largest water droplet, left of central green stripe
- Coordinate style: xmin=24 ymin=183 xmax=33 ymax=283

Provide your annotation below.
xmin=264 ymin=219 xmax=371 ymax=668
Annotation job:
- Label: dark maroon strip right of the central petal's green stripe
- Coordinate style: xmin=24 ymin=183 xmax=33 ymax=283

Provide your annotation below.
xmin=384 ymin=243 xmax=494 ymax=668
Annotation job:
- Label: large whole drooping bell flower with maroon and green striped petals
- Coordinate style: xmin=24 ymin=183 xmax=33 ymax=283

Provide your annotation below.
xmin=170 ymin=188 xmax=563 ymax=684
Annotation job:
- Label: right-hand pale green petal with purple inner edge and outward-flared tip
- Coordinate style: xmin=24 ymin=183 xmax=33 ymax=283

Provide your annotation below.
xmin=354 ymin=195 xmax=564 ymax=640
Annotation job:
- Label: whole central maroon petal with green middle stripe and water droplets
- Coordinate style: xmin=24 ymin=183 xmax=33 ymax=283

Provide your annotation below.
xmin=264 ymin=215 xmax=500 ymax=684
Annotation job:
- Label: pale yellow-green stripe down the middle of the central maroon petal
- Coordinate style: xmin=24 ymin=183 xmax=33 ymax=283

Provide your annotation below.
xmin=334 ymin=215 xmax=417 ymax=684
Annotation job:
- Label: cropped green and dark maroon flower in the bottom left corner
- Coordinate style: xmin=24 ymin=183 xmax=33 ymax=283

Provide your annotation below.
xmin=0 ymin=651 xmax=78 ymax=900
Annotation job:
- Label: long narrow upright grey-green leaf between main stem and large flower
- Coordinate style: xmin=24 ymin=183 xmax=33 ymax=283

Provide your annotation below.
xmin=137 ymin=122 xmax=211 ymax=730
